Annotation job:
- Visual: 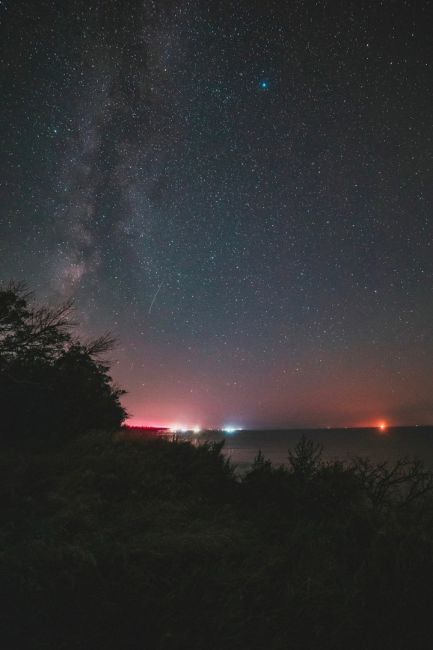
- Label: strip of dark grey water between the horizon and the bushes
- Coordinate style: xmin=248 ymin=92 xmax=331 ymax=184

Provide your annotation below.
xmin=174 ymin=426 xmax=433 ymax=470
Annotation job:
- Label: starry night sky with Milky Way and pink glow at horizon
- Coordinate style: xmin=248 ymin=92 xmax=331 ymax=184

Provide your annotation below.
xmin=0 ymin=0 xmax=433 ymax=427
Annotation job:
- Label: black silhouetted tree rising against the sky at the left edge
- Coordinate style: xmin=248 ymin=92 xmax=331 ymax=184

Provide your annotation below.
xmin=0 ymin=283 xmax=126 ymax=437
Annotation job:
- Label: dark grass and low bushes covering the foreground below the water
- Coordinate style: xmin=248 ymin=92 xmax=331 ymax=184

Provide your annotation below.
xmin=0 ymin=434 xmax=433 ymax=650
